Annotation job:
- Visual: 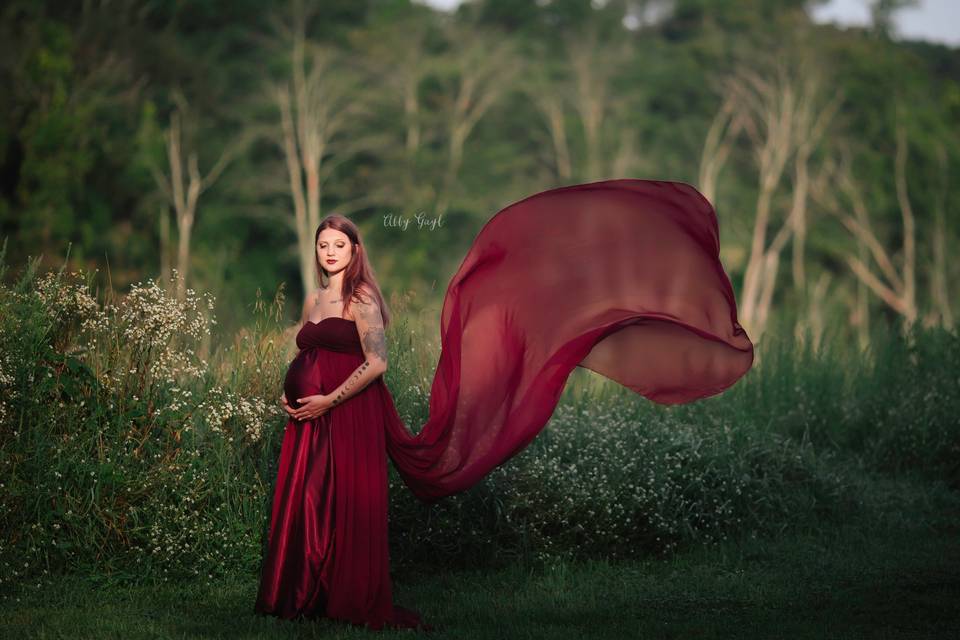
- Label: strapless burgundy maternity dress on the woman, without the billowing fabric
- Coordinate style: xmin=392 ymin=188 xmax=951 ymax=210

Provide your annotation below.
xmin=254 ymin=317 xmax=421 ymax=629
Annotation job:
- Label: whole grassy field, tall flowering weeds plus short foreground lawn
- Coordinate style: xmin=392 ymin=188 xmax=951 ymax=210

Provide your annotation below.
xmin=0 ymin=259 xmax=960 ymax=639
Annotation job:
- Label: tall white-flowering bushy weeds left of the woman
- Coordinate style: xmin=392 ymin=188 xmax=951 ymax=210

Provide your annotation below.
xmin=0 ymin=258 xmax=283 ymax=592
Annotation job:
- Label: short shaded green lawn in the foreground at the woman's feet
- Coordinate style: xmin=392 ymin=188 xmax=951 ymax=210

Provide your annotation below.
xmin=0 ymin=478 xmax=960 ymax=640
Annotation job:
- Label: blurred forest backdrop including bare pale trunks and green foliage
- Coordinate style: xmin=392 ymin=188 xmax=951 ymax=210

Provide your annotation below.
xmin=0 ymin=0 xmax=960 ymax=346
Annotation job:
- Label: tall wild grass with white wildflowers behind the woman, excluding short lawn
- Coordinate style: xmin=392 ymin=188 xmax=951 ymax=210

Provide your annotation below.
xmin=0 ymin=255 xmax=960 ymax=594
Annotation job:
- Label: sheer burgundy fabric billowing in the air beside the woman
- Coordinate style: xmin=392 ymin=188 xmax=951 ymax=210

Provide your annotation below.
xmin=386 ymin=179 xmax=753 ymax=502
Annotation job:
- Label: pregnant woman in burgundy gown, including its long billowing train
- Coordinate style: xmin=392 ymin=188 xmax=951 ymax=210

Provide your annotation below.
xmin=254 ymin=180 xmax=753 ymax=629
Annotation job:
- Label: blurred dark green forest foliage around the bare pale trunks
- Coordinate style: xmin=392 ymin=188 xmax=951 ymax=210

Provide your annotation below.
xmin=0 ymin=0 xmax=960 ymax=340
